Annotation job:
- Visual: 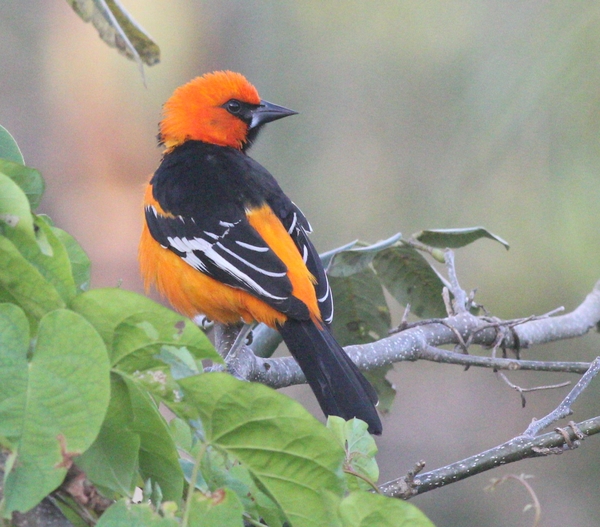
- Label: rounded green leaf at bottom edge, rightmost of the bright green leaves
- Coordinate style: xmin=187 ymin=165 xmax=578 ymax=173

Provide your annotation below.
xmin=339 ymin=492 xmax=435 ymax=527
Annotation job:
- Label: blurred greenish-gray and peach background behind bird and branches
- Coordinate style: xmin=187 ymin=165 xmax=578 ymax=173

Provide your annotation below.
xmin=0 ymin=0 xmax=600 ymax=527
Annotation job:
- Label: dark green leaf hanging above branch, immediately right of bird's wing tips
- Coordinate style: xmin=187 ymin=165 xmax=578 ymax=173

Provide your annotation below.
xmin=329 ymin=267 xmax=391 ymax=346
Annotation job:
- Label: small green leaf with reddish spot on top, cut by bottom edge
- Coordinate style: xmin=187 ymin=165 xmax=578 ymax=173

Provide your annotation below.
xmin=189 ymin=488 xmax=244 ymax=527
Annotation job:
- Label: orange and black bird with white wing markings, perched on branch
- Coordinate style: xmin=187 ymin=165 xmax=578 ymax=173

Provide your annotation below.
xmin=138 ymin=71 xmax=382 ymax=434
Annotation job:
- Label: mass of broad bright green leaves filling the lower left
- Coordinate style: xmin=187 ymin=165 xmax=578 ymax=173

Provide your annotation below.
xmin=0 ymin=129 xmax=440 ymax=527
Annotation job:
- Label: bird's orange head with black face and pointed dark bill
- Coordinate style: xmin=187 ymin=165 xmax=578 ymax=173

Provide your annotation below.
xmin=159 ymin=71 xmax=296 ymax=149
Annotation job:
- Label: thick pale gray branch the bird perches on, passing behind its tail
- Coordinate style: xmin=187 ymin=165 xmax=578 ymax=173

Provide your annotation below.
xmin=237 ymin=282 xmax=600 ymax=388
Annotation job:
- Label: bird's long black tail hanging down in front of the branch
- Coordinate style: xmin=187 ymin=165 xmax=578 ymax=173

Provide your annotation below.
xmin=278 ymin=318 xmax=382 ymax=435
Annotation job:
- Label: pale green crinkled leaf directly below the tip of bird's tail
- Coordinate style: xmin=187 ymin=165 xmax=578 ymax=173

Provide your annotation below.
xmin=327 ymin=416 xmax=379 ymax=491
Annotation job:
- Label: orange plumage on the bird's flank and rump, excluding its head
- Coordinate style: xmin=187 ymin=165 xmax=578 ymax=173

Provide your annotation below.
xmin=139 ymin=185 xmax=321 ymax=327
